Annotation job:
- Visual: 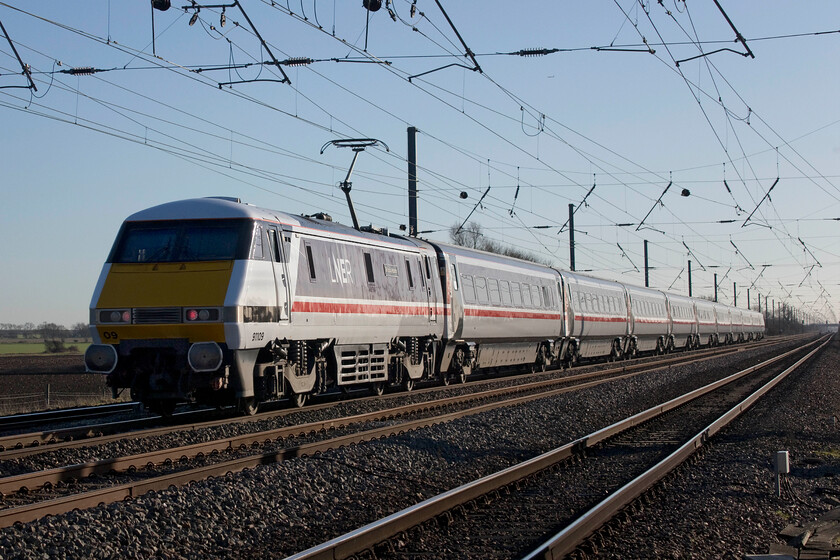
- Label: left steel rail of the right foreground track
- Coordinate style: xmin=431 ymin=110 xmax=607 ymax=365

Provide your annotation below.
xmin=287 ymin=341 xmax=819 ymax=560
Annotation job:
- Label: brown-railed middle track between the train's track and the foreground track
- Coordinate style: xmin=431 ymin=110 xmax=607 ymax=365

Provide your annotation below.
xmin=0 ymin=334 xmax=800 ymax=526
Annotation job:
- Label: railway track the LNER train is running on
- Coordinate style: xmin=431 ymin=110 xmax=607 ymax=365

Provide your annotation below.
xmin=0 ymin=337 xmax=798 ymax=461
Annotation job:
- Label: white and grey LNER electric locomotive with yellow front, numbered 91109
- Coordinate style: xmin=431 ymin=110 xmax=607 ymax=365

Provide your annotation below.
xmin=85 ymin=198 xmax=444 ymax=414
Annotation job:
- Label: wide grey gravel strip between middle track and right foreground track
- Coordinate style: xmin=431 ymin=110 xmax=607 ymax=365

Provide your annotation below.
xmin=0 ymin=334 xmax=808 ymax=558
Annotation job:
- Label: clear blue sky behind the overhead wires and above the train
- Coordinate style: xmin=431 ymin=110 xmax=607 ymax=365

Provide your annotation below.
xmin=0 ymin=0 xmax=840 ymax=325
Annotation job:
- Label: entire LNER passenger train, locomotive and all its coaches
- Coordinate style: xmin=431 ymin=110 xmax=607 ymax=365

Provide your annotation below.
xmin=85 ymin=197 xmax=764 ymax=414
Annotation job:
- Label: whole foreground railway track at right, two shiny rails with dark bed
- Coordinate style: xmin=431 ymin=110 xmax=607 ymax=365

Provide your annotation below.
xmin=280 ymin=339 xmax=827 ymax=560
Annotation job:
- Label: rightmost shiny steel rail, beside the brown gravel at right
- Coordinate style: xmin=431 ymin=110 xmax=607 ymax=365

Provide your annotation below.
xmin=523 ymin=336 xmax=831 ymax=560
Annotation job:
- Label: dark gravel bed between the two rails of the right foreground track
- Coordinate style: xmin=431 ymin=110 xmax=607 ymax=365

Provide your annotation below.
xmin=377 ymin=348 xmax=808 ymax=560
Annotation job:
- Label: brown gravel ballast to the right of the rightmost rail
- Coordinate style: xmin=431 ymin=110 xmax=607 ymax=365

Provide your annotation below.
xmin=598 ymin=336 xmax=840 ymax=560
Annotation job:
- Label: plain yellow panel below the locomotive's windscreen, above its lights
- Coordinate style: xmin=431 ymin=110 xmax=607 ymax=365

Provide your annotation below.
xmin=96 ymin=261 xmax=233 ymax=309
